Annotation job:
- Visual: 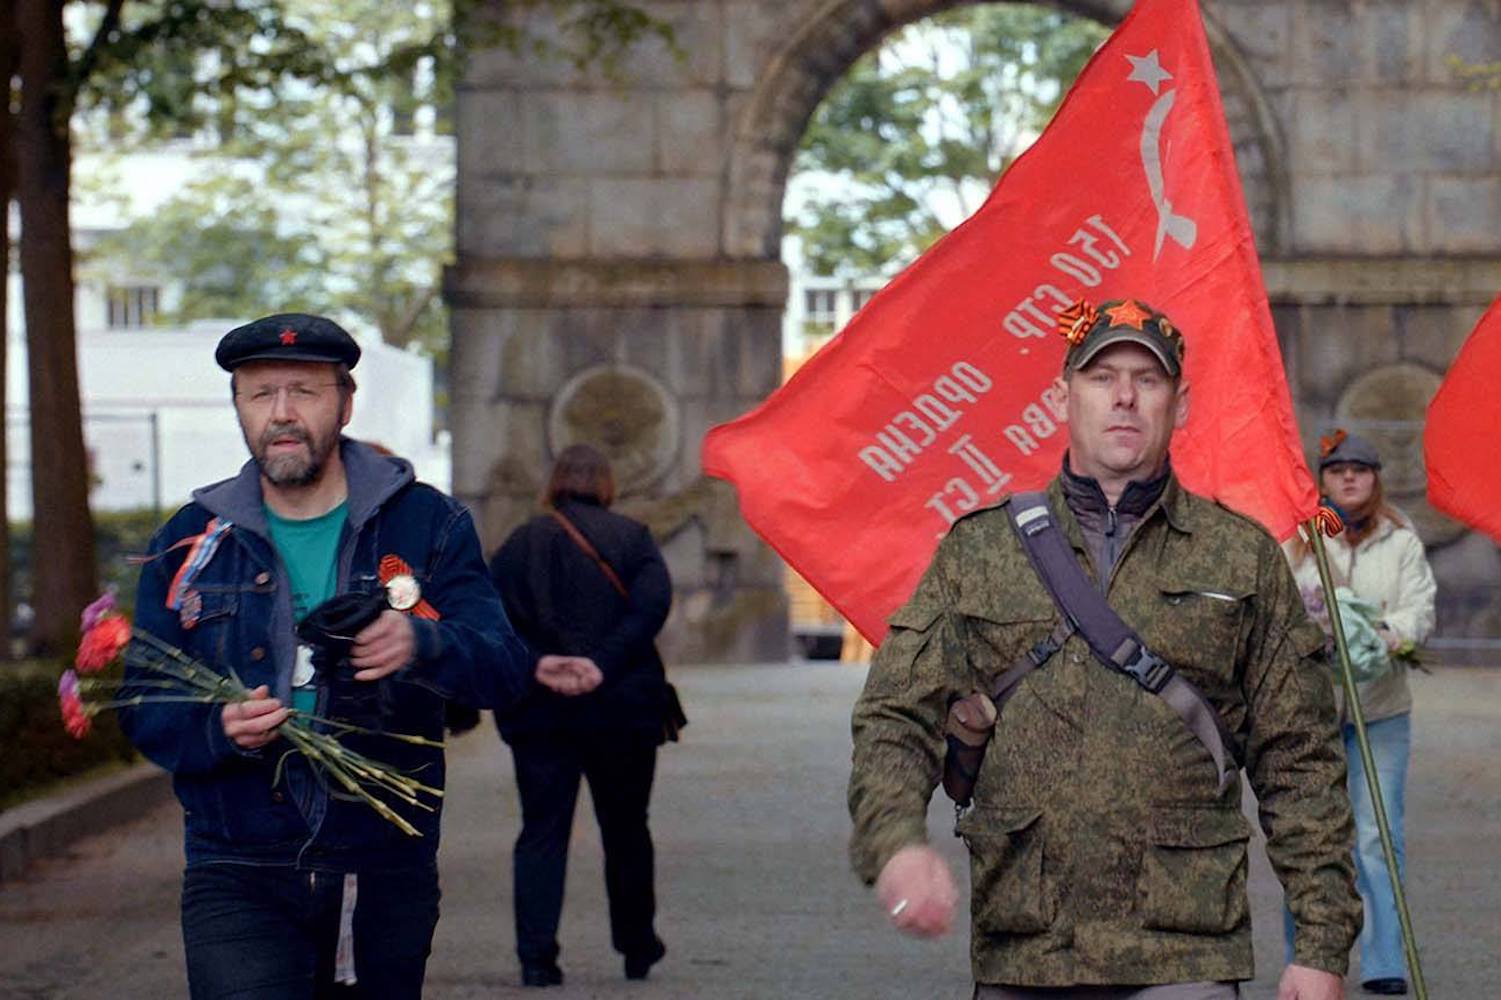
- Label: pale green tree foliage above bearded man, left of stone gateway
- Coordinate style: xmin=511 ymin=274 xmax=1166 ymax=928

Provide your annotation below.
xmin=77 ymin=0 xmax=660 ymax=354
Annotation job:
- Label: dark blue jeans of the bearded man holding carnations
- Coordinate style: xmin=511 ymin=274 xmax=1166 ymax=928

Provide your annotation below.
xmin=182 ymin=863 xmax=438 ymax=1000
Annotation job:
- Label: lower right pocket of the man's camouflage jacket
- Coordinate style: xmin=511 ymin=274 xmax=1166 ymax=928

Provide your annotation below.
xmin=1141 ymin=809 xmax=1250 ymax=934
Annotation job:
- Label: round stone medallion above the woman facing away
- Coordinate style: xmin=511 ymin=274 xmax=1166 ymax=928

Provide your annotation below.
xmin=548 ymin=365 xmax=678 ymax=494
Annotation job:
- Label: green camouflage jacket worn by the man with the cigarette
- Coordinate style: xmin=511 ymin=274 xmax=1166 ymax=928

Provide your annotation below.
xmin=850 ymin=479 xmax=1361 ymax=986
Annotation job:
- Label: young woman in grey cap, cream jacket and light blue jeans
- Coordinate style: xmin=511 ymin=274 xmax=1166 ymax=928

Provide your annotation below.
xmin=1288 ymin=429 xmax=1433 ymax=995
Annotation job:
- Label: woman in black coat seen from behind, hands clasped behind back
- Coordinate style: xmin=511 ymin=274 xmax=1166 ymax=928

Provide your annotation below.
xmin=489 ymin=444 xmax=672 ymax=986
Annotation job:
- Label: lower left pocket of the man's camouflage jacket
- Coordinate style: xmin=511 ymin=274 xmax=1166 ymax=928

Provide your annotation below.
xmin=958 ymin=806 xmax=1057 ymax=934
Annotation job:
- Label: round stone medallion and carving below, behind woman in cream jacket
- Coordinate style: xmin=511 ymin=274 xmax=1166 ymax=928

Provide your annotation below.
xmin=1319 ymin=363 xmax=1465 ymax=545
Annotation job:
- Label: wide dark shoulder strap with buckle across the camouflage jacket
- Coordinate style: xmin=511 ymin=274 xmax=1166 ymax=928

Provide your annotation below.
xmin=1007 ymin=492 xmax=1238 ymax=791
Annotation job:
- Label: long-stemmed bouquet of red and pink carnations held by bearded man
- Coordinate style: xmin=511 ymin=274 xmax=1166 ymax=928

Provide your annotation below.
xmin=57 ymin=593 xmax=443 ymax=836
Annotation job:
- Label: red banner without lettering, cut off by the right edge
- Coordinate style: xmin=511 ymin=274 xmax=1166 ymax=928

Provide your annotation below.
xmin=1423 ymin=299 xmax=1501 ymax=542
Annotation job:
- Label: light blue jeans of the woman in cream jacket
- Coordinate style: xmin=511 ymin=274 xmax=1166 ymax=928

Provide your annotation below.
xmin=1283 ymin=712 xmax=1412 ymax=982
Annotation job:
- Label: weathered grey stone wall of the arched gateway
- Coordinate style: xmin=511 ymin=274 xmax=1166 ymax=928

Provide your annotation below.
xmin=447 ymin=0 xmax=1501 ymax=659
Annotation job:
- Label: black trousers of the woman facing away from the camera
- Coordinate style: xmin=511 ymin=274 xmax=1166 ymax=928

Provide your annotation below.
xmin=510 ymin=734 xmax=656 ymax=965
